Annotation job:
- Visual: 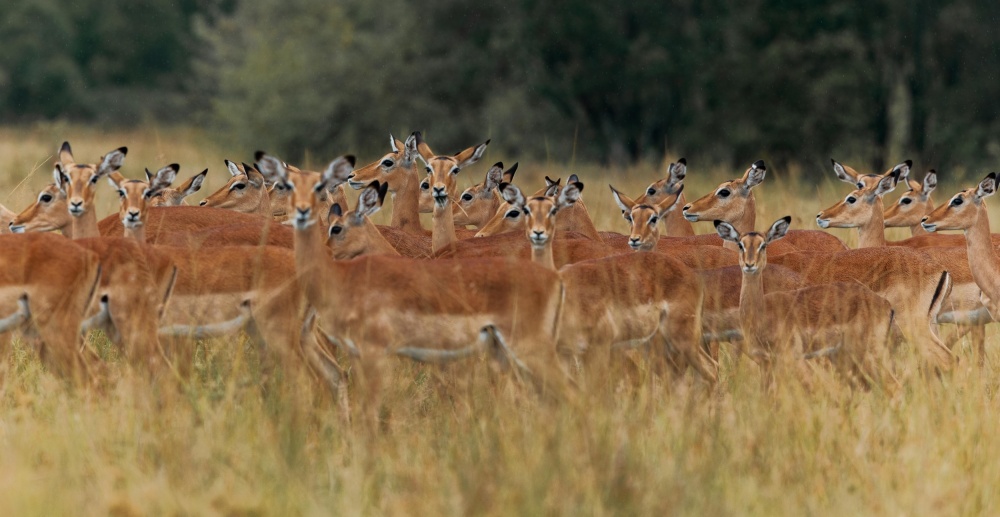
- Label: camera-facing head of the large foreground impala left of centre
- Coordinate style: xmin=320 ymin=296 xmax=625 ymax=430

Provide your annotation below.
xmin=257 ymin=152 xmax=354 ymax=230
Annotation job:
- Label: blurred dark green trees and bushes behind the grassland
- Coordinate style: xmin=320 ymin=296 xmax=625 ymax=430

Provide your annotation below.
xmin=0 ymin=0 xmax=1000 ymax=175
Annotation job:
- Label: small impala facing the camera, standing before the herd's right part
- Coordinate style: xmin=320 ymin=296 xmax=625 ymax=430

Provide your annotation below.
xmin=715 ymin=217 xmax=893 ymax=388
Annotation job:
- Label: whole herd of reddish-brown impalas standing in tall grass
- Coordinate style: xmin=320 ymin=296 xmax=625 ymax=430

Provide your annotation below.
xmin=0 ymin=133 xmax=1000 ymax=397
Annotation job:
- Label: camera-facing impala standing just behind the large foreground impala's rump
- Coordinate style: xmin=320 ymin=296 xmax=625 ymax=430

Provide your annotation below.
xmin=500 ymin=181 xmax=717 ymax=383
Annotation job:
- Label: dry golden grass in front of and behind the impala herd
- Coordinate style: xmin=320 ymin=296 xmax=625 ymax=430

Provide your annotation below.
xmin=0 ymin=125 xmax=1000 ymax=515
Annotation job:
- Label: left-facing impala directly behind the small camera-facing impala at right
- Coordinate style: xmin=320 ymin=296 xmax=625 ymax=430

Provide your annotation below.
xmin=682 ymin=160 xmax=847 ymax=252
